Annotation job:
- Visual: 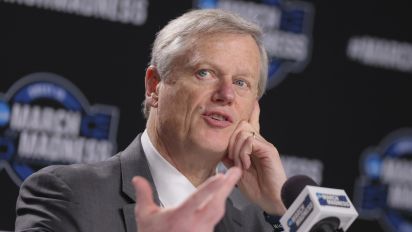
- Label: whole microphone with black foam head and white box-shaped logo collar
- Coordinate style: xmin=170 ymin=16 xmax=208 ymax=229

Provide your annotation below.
xmin=280 ymin=175 xmax=358 ymax=232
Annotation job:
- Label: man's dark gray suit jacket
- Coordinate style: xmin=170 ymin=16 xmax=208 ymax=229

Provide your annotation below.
xmin=16 ymin=135 xmax=273 ymax=232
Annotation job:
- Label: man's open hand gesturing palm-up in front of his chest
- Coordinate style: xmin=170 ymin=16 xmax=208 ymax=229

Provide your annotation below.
xmin=132 ymin=167 xmax=242 ymax=232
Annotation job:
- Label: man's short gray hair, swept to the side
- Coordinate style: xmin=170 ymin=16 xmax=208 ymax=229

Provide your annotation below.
xmin=142 ymin=9 xmax=268 ymax=118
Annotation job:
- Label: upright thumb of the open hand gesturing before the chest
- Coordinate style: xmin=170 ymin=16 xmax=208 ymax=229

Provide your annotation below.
xmin=132 ymin=176 xmax=159 ymax=218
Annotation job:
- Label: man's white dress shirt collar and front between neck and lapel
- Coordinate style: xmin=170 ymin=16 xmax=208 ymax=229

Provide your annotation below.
xmin=141 ymin=130 xmax=196 ymax=207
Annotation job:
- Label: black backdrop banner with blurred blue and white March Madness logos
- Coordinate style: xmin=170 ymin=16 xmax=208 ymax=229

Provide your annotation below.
xmin=0 ymin=0 xmax=412 ymax=232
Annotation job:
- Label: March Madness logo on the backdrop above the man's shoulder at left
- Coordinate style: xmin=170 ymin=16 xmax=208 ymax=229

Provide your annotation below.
xmin=0 ymin=73 xmax=118 ymax=185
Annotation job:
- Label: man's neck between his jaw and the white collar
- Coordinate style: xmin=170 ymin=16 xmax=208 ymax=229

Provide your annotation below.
xmin=146 ymin=114 xmax=220 ymax=187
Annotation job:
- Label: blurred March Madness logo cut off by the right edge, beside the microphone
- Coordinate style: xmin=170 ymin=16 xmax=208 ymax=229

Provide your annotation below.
xmin=355 ymin=129 xmax=412 ymax=232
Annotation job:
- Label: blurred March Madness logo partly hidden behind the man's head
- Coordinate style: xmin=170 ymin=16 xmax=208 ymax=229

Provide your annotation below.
xmin=194 ymin=0 xmax=314 ymax=88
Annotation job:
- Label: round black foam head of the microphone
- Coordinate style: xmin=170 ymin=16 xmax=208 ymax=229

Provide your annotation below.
xmin=280 ymin=175 xmax=318 ymax=209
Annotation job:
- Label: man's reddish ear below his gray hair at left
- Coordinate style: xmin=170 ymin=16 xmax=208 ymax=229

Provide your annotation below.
xmin=145 ymin=65 xmax=160 ymax=107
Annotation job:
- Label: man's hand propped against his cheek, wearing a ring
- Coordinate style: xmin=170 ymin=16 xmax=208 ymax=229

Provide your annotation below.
xmin=223 ymin=101 xmax=286 ymax=215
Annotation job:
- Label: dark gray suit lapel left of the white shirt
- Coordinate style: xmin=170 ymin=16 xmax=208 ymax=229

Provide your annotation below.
xmin=120 ymin=134 xmax=160 ymax=232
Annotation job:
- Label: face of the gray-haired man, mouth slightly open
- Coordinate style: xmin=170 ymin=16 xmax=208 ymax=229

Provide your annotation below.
xmin=155 ymin=34 xmax=260 ymax=158
